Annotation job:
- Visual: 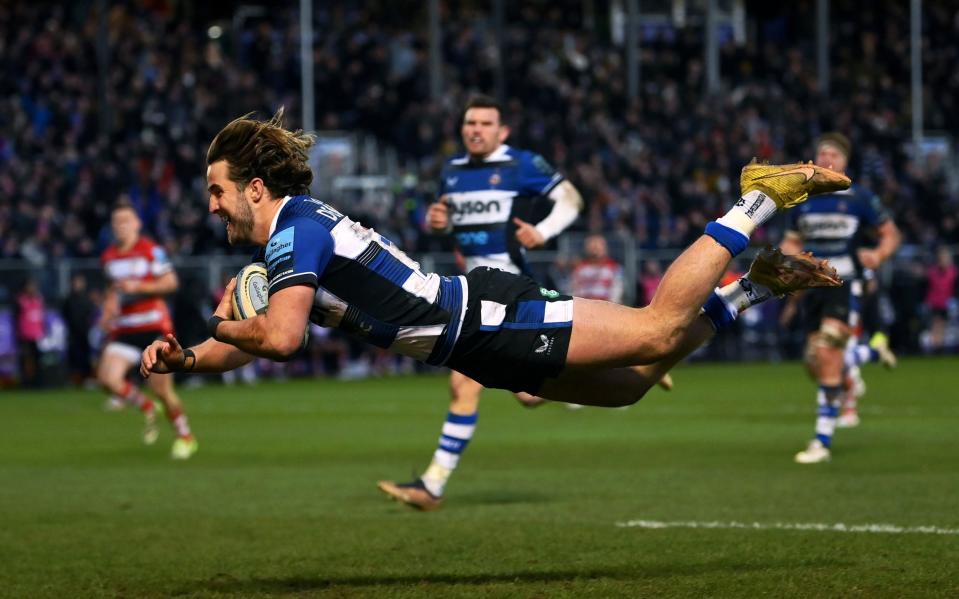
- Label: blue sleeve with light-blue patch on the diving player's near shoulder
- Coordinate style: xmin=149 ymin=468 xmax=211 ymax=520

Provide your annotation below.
xmin=265 ymin=217 xmax=333 ymax=295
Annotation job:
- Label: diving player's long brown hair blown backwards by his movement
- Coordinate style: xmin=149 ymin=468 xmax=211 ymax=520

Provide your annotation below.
xmin=206 ymin=107 xmax=316 ymax=198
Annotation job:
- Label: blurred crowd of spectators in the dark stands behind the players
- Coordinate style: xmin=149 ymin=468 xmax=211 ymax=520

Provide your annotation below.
xmin=0 ymin=0 xmax=959 ymax=390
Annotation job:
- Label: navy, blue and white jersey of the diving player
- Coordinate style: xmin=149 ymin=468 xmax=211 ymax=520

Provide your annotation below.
xmin=254 ymin=196 xmax=467 ymax=365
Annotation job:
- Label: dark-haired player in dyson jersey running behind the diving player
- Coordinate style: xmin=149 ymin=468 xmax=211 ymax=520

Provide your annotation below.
xmin=378 ymin=96 xmax=583 ymax=510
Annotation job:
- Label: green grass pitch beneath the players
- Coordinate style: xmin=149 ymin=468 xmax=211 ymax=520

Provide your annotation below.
xmin=0 ymin=359 xmax=959 ymax=597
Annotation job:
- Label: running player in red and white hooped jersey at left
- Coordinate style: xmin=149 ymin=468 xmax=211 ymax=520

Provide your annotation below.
xmin=97 ymin=204 xmax=197 ymax=460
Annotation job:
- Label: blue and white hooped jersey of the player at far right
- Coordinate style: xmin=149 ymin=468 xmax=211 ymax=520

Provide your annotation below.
xmin=790 ymin=185 xmax=890 ymax=278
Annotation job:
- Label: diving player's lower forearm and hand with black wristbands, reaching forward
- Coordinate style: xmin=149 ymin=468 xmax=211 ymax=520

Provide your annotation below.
xmin=140 ymin=335 xmax=253 ymax=378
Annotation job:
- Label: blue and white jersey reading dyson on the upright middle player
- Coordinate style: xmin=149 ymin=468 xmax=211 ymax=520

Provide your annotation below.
xmin=440 ymin=144 xmax=563 ymax=273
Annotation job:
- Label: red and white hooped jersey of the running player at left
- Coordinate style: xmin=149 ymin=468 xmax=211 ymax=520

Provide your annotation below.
xmin=100 ymin=237 xmax=173 ymax=337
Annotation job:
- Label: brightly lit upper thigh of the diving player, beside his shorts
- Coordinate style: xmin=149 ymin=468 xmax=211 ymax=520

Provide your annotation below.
xmin=564 ymin=297 xmax=668 ymax=368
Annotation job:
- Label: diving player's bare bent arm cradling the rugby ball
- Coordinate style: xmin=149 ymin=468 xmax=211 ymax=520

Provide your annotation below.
xmin=211 ymin=280 xmax=316 ymax=360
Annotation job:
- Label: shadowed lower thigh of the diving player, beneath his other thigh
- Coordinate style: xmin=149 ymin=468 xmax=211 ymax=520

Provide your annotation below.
xmin=538 ymin=368 xmax=651 ymax=407
